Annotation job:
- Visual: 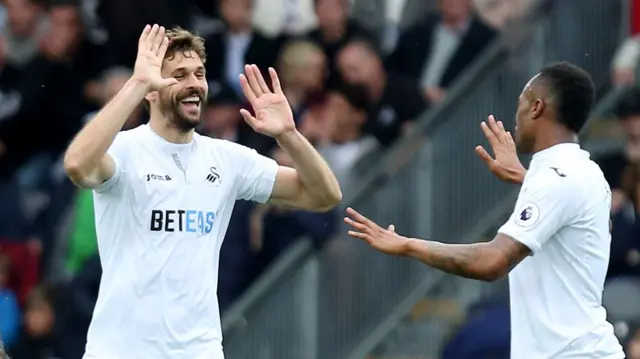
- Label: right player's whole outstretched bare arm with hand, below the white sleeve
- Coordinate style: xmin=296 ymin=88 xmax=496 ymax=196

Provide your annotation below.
xmin=345 ymin=208 xmax=531 ymax=281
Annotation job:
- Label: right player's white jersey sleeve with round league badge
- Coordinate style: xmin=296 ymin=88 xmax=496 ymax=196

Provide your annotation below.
xmin=498 ymin=169 xmax=579 ymax=254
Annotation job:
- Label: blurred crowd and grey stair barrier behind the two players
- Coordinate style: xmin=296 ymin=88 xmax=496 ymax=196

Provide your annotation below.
xmin=0 ymin=0 xmax=640 ymax=359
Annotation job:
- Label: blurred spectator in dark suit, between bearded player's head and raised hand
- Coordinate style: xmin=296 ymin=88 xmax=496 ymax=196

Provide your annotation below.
xmin=206 ymin=0 xmax=281 ymax=97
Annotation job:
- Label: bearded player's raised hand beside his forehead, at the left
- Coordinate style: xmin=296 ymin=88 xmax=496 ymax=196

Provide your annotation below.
xmin=133 ymin=24 xmax=178 ymax=91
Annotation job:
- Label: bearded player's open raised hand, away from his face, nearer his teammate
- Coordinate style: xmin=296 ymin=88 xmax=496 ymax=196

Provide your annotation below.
xmin=240 ymin=65 xmax=296 ymax=138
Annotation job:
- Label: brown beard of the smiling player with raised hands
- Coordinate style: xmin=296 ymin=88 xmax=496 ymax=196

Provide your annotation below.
xmin=160 ymin=89 xmax=206 ymax=132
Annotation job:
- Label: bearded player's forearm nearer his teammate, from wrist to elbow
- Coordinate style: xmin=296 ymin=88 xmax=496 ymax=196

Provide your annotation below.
xmin=276 ymin=130 xmax=342 ymax=207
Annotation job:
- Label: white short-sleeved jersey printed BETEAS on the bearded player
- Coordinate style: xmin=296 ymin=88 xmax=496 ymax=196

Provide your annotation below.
xmin=84 ymin=125 xmax=278 ymax=359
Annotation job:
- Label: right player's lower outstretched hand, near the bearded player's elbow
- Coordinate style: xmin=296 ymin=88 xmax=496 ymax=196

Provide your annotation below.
xmin=344 ymin=208 xmax=410 ymax=255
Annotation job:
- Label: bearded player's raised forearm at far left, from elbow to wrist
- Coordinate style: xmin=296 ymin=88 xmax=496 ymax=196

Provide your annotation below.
xmin=64 ymin=79 xmax=147 ymax=173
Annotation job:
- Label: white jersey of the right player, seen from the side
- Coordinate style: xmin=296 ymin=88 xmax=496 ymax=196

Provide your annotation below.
xmin=498 ymin=144 xmax=624 ymax=359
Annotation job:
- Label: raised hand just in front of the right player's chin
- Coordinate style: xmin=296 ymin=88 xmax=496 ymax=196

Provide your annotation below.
xmin=476 ymin=115 xmax=527 ymax=184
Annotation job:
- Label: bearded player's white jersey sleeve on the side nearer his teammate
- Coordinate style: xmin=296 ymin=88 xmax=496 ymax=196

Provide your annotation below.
xmin=229 ymin=142 xmax=279 ymax=203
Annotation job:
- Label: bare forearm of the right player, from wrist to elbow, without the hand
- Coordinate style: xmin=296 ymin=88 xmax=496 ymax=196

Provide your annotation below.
xmin=404 ymin=239 xmax=504 ymax=281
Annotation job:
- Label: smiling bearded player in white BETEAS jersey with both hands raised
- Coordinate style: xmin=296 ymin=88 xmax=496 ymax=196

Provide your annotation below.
xmin=64 ymin=25 xmax=342 ymax=359
